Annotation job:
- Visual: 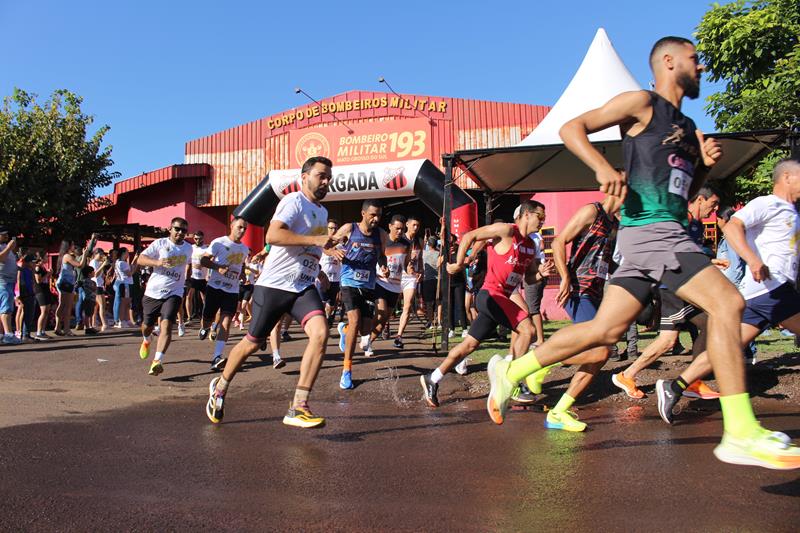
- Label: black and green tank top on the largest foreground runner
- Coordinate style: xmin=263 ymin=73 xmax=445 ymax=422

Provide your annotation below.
xmin=620 ymin=91 xmax=700 ymax=226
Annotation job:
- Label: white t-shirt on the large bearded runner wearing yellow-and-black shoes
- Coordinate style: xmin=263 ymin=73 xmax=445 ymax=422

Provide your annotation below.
xmin=256 ymin=191 xmax=328 ymax=292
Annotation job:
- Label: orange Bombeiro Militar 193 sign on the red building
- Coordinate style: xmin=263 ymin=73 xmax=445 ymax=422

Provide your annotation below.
xmin=289 ymin=118 xmax=432 ymax=168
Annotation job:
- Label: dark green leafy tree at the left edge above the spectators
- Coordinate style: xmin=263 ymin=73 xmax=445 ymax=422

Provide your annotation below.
xmin=0 ymin=89 xmax=118 ymax=243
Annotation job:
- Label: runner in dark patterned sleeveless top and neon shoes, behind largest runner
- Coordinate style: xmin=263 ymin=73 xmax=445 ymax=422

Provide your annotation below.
xmin=526 ymin=195 xmax=622 ymax=431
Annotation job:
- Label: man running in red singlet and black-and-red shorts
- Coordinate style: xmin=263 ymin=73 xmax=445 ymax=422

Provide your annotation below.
xmin=420 ymin=200 xmax=543 ymax=407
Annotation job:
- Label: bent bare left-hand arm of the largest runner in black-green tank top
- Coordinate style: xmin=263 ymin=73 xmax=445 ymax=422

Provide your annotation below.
xmin=558 ymin=91 xmax=653 ymax=199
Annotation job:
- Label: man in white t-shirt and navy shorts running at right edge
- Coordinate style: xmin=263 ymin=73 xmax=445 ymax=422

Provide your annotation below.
xmin=656 ymin=159 xmax=800 ymax=432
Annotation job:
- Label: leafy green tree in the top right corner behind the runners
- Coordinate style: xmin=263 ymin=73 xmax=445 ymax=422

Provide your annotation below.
xmin=695 ymin=0 xmax=800 ymax=203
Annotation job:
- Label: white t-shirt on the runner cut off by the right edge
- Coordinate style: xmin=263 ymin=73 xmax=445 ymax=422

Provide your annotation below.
xmin=733 ymin=194 xmax=800 ymax=300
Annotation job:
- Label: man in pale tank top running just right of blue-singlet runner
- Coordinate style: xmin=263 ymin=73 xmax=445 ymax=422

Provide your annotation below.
xmin=362 ymin=215 xmax=412 ymax=357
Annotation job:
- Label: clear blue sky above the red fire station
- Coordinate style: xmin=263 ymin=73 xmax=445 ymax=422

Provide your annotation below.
xmin=0 ymin=0 xmax=728 ymax=192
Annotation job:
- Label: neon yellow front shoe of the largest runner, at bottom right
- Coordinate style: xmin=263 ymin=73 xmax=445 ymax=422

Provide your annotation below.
xmin=714 ymin=427 xmax=800 ymax=470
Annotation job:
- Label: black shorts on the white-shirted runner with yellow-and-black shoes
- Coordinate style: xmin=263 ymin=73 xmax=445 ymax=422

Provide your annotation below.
xmin=248 ymin=285 xmax=325 ymax=344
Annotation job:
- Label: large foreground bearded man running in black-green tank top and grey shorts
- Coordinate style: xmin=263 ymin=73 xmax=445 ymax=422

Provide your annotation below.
xmin=487 ymin=37 xmax=800 ymax=468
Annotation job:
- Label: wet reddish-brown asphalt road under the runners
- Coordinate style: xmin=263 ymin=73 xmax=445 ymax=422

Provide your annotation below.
xmin=0 ymin=324 xmax=800 ymax=531
